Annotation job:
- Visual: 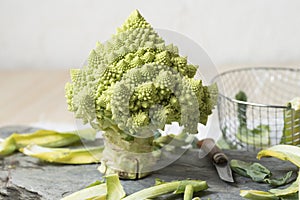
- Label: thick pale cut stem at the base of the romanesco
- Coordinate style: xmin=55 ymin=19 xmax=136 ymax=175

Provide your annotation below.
xmin=98 ymin=129 xmax=160 ymax=179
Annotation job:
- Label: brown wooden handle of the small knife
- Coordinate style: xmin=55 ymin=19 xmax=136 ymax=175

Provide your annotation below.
xmin=197 ymin=138 xmax=228 ymax=164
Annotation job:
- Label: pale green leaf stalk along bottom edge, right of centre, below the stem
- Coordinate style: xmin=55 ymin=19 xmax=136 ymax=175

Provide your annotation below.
xmin=123 ymin=180 xmax=208 ymax=200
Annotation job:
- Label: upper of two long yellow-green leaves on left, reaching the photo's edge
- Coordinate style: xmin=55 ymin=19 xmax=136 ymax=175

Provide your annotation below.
xmin=0 ymin=129 xmax=96 ymax=156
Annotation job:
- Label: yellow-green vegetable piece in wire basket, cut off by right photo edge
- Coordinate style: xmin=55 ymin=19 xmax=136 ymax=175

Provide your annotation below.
xmin=281 ymin=97 xmax=300 ymax=145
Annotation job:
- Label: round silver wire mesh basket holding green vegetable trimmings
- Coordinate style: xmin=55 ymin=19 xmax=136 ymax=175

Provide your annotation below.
xmin=213 ymin=67 xmax=300 ymax=151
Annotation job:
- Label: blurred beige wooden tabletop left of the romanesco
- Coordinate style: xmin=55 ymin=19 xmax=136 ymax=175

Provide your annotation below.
xmin=0 ymin=69 xmax=74 ymax=126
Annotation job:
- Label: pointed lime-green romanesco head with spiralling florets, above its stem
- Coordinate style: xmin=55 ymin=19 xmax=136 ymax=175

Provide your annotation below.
xmin=66 ymin=10 xmax=215 ymax=178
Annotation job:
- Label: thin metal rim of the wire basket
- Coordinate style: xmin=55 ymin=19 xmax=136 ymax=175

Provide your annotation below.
xmin=211 ymin=67 xmax=300 ymax=109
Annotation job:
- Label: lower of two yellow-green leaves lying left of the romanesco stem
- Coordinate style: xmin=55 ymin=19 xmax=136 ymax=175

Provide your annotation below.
xmin=20 ymin=145 xmax=104 ymax=164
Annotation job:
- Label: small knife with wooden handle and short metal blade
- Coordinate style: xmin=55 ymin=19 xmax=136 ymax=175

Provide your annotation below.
xmin=197 ymin=138 xmax=234 ymax=183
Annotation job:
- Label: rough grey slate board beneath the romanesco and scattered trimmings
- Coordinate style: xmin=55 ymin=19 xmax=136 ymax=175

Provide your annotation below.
xmin=0 ymin=126 xmax=297 ymax=200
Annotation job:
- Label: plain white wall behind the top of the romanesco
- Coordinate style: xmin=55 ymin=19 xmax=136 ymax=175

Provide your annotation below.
xmin=0 ymin=0 xmax=300 ymax=70
